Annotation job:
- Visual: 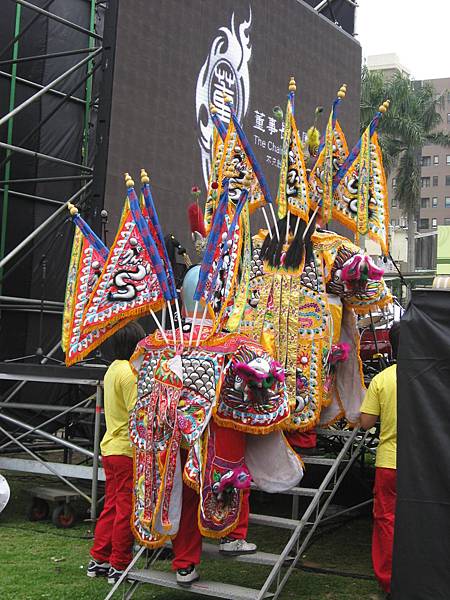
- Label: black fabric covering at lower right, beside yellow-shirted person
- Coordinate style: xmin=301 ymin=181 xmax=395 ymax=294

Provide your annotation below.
xmin=392 ymin=290 xmax=450 ymax=600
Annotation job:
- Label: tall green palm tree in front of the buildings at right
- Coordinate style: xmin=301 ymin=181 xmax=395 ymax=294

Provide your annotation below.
xmin=361 ymin=67 xmax=450 ymax=272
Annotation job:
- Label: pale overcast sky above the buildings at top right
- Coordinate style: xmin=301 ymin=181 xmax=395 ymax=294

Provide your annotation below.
xmin=355 ymin=0 xmax=450 ymax=79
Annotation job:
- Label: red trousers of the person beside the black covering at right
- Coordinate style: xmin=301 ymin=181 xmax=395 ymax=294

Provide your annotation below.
xmin=372 ymin=467 xmax=397 ymax=593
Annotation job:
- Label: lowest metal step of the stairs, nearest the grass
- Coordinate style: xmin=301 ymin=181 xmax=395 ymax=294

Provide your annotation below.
xmin=128 ymin=569 xmax=273 ymax=600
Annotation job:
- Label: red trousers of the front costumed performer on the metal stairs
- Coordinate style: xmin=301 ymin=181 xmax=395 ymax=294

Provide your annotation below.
xmin=172 ymin=423 xmax=250 ymax=571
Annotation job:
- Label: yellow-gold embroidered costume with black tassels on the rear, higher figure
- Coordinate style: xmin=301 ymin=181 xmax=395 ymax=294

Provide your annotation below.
xmin=243 ymin=218 xmax=391 ymax=431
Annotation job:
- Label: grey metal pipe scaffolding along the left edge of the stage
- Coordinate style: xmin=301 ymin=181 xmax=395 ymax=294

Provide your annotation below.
xmin=0 ymin=0 xmax=106 ymax=519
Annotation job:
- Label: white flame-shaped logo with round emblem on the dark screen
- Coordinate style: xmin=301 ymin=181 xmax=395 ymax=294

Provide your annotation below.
xmin=196 ymin=8 xmax=252 ymax=183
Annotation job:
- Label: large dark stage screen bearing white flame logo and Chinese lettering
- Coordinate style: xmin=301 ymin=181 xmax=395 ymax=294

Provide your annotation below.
xmin=93 ymin=0 xmax=361 ymax=247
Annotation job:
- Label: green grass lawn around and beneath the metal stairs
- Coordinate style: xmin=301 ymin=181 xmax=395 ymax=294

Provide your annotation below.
xmin=0 ymin=474 xmax=381 ymax=600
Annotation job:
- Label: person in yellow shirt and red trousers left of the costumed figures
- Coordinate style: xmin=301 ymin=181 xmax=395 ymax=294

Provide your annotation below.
xmin=87 ymin=322 xmax=145 ymax=583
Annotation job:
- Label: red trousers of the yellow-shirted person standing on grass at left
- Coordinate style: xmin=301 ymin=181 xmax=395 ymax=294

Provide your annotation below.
xmin=91 ymin=456 xmax=133 ymax=570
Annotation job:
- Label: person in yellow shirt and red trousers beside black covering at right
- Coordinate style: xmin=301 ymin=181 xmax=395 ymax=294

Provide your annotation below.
xmin=360 ymin=323 xmax=400 ymax=598
